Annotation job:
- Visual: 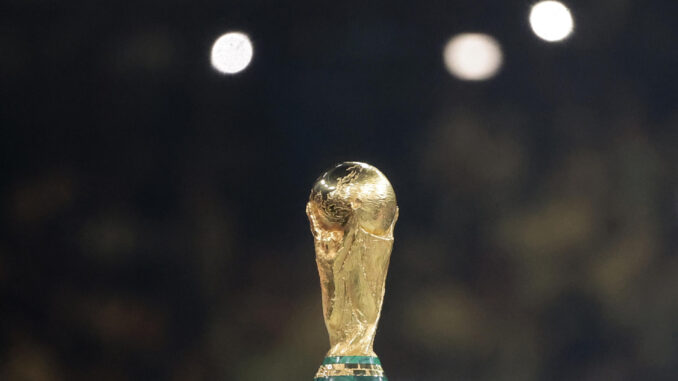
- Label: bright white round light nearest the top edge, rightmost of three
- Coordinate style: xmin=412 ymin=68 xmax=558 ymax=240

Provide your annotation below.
xmin=530 ymin=1 xmax=574 ymax=42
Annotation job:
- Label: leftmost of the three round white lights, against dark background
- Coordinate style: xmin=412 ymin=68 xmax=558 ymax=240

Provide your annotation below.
xmin=212 ymin=32 xmax=253 ymax=74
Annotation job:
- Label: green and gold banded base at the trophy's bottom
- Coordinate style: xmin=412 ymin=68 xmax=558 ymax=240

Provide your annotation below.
xmin=313 ymin=356 xmax=388 ymax=381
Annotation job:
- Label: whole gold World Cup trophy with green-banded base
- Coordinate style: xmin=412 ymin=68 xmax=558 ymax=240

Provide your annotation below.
xmin=306 ymin=162 xmax=398 ymax=381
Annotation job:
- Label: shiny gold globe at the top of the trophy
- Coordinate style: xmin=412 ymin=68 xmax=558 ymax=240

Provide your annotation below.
xmin=309 ymin=162 xmax=398 ymax=236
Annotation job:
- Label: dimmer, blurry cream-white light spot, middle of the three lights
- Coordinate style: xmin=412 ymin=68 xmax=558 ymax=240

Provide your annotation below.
xmin=443 ymin=33 xmax=503 ymax=81
